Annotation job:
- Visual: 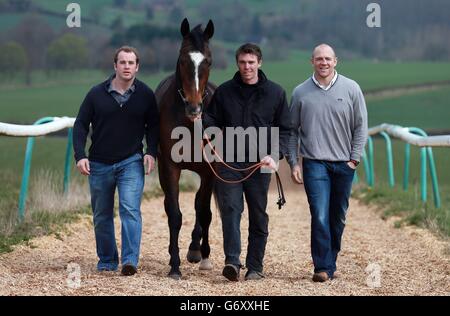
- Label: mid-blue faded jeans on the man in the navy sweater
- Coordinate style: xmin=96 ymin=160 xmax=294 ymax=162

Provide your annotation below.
xmin=89 ymin=154 xmax=144 ymax=271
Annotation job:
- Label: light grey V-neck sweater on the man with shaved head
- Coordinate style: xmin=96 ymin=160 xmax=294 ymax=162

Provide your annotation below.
xmin=287 ymin=74 xmax=367 ymax=168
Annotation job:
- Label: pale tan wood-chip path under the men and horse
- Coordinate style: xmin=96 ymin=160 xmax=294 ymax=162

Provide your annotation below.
xmin=0 ymin=186 xmax=450 ymax=296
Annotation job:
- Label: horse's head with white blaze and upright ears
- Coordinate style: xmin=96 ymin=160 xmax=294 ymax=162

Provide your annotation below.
xmin=177 ymin=18 xmax=214 ymax=121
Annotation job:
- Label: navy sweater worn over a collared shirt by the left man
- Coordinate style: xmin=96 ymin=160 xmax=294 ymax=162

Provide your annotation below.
xmin=73 ymin=79 xmax=159 ymax=164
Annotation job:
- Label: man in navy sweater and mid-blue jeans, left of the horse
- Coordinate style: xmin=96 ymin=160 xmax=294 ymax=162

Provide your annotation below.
xmin=73 ymin=46 xmax=159 ymax=275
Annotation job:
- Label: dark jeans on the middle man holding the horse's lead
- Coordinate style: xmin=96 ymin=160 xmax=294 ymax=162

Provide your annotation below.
xmin=215 ymin=164 xmax=271 ymax=272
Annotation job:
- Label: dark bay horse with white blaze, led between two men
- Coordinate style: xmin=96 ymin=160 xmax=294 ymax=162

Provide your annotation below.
xmin=155 ymin=19 xmax=216 ymax=280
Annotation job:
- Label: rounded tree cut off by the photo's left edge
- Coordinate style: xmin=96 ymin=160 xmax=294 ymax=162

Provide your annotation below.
xmin=0 ymin=41 xmax=28 ymax=78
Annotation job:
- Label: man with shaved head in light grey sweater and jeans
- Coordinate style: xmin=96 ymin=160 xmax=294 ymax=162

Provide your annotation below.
xmin=287 ymin=44 xmax=367 ymax=282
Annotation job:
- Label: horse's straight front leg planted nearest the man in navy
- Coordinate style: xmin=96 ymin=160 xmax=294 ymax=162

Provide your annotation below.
xmin=158 ymin=160 xmax=182 ymax=280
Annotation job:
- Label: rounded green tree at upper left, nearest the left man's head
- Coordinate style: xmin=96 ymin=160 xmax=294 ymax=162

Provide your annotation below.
xmin=47 ymin=33 xmax=88 ymax=70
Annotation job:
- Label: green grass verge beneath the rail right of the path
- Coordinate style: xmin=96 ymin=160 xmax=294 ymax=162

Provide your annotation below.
xmin=354 ymin=138 xmax=450 ymax=236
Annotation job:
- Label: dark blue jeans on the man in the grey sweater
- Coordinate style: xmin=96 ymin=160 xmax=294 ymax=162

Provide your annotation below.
xmin=303 ymin=158 xmax=355 ymax=278
